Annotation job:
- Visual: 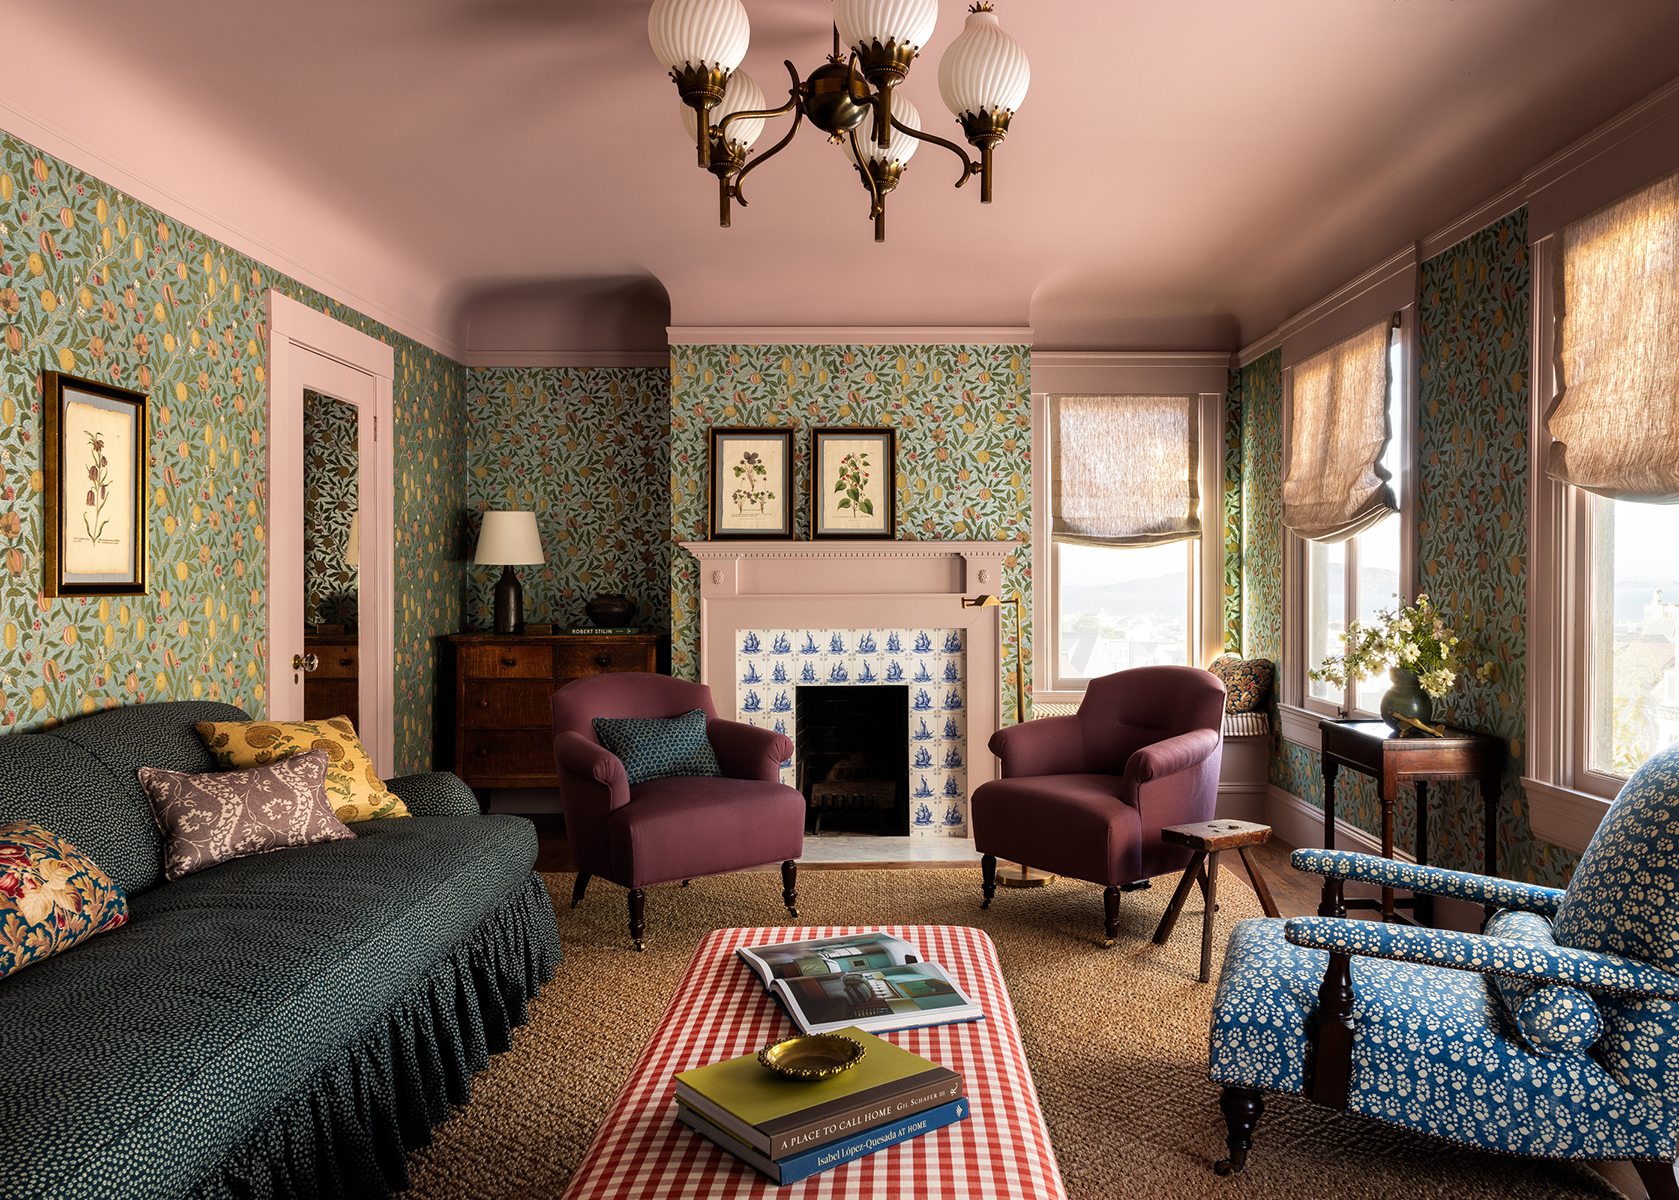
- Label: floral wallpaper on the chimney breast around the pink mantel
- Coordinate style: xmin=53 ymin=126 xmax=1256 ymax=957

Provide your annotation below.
xmin=670 ymin=346 xmax=1031 ymax=713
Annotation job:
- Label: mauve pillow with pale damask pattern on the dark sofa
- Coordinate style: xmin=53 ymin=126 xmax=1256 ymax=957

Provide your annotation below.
xmin=139 ymin=750 xmax=356 ymax=881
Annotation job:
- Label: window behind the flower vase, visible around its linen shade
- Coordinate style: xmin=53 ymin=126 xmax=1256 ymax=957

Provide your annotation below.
xmin=1300 ymin=329 xmax=1410 ymax=717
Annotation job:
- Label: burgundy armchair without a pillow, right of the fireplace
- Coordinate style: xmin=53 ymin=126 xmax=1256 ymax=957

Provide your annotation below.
xmin=972 ymin=666 xmax=1224 ymax=945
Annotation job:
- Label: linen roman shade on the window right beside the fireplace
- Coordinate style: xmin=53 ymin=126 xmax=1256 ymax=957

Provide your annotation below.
xmin=1049 ymin=396 xmax=1200 ymax=545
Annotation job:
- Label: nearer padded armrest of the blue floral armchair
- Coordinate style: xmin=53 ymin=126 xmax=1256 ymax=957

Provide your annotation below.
xmin=1283 ymin=916 xmax=1679 ymax=1000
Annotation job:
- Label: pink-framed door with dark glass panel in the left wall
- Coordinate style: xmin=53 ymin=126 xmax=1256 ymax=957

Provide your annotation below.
xmin=265 ymin=290 xmax=396 ymax=779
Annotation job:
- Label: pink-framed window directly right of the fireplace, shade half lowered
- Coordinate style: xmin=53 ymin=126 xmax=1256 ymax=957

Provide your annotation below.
xmin=1033 ymin=384 xmax=1229 ymax=703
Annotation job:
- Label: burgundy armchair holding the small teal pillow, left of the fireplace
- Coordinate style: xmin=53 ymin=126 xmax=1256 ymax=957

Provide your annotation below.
xmin=551 ymin=671 xmax=804 ymax=950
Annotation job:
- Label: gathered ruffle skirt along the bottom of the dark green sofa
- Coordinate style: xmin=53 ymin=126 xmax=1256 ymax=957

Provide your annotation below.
xmin=188 ymin=873 xmax=561 ymax=1200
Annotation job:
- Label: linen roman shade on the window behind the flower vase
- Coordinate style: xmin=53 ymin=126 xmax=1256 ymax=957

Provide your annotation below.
xmin=1283 ymin=321 xmax=1399 ymax=542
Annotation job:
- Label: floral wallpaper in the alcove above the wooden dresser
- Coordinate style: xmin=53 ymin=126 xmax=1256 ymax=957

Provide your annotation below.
xmin=465 ymin=368 xmax=672 ymax=629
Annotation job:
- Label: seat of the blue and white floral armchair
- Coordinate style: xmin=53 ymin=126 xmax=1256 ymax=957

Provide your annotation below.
xmin=1207 ymin=920 xmax=1674 ymax=1158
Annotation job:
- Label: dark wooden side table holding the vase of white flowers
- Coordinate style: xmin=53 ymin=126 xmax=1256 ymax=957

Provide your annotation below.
xmin=1318 ymin=720 xmax=1504 ymax=925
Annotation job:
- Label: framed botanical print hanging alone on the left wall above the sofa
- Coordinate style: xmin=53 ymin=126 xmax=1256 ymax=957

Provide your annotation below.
xmin=42 ymin=371 xmax=149 ymax=596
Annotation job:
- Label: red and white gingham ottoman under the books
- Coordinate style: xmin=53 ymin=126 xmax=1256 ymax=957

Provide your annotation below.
xmin=564 ymin=925 xmax=1066 ymax=1200
